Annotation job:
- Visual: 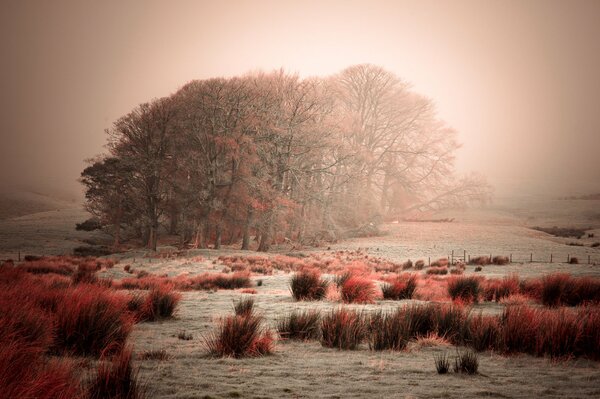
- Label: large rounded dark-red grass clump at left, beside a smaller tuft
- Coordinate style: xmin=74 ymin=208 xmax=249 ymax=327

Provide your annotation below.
xmin=54 ymin=285 xmax=133 ymax=356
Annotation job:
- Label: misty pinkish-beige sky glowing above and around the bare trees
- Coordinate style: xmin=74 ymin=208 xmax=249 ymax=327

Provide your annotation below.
xmin=0 ymin=0 xmax=600 ymax=200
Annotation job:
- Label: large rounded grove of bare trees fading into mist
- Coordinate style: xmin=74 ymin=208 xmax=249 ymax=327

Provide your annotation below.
xmin=81 ymin=65 xmax=488 ymax=251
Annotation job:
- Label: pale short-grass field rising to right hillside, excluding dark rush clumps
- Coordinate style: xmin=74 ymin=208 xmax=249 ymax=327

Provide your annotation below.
xmin=0 ymin=201 xmax=600 ymax=398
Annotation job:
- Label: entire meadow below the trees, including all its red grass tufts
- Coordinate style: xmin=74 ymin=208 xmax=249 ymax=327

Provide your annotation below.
xmin=0 ymin=200 xmax=600 ymax=398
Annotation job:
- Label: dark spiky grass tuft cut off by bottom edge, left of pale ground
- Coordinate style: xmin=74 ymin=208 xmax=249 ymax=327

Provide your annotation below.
xmin=88 ymin=349 xmax=145 ymax=399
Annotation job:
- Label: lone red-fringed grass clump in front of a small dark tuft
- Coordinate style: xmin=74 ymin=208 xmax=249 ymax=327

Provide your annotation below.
xmin=204 ymin=315 xmax=273 ymax=358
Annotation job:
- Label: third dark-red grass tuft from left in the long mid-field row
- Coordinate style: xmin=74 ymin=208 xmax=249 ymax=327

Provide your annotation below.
xmin=369 ymin=309 xmax=411 ymax=351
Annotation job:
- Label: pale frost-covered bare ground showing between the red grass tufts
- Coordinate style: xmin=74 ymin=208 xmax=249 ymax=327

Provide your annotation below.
xmin=0 ymin=200 xmax=600 ymax=398
